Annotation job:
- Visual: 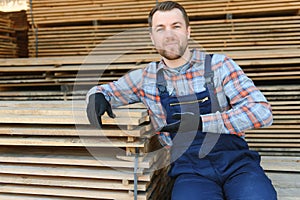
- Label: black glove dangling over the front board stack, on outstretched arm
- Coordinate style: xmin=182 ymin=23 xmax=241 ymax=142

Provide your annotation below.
xmin=86 ymin=93 xmax=116 ymax=128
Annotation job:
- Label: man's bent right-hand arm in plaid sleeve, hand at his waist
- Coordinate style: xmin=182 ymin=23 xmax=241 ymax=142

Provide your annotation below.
xmin=201 ymin=55 xmax=273 ymax=135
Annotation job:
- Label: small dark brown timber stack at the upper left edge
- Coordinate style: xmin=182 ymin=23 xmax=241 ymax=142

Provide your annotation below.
xmin=0 ymin=12 xmax=17 ymax=58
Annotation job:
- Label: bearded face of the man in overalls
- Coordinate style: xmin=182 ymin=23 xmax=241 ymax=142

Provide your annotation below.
xmin=150 ymin=8 xmax=190 ymax=60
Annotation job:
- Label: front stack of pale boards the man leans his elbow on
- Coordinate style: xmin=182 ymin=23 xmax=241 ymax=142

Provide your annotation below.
xmin=0 ymin=101 xmax=171 ymax=200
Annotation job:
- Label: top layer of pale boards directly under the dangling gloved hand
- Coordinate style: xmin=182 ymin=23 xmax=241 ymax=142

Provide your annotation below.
xmin=0 ymin=102 xmax=149 ymax=126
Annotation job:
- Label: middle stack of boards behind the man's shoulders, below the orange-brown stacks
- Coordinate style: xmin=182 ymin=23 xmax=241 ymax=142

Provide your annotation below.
xmin=0 ymin=47 xmax=300 ymax=95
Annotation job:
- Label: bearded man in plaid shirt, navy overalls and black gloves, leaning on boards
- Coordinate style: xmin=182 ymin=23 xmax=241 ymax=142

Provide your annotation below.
xmin=87 ymin=1 xmax=276 ymax=200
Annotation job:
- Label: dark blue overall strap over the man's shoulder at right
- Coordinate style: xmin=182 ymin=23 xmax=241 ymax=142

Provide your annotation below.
xmin=204 ymin=54 xmax=221 ymax=113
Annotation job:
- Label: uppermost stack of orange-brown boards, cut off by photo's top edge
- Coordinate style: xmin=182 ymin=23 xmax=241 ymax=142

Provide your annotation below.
xmin=27 ymin=0 xmax=300 ymax=27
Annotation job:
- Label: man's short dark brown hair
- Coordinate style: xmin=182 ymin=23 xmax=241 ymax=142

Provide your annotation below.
xmin=148 ymin=1 xmax=190 ymax=28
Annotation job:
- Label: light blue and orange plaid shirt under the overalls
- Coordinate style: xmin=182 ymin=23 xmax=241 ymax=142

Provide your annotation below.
xmin=87 ymin=50 xmax=273 ymax=146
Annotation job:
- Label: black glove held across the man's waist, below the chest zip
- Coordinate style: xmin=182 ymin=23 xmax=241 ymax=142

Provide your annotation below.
xmin=159 ymin=112 xmax=202 ymax=133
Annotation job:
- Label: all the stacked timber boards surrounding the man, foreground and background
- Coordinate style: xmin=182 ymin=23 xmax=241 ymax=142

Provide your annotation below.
xmin=0 ymin=0 xmax=300 ymax=200
